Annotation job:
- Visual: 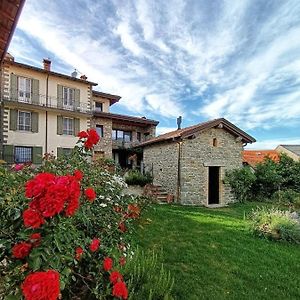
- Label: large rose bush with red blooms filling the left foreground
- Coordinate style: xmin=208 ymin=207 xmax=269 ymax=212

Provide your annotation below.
xmin=0 ymin=129 xmax=150 ymax=300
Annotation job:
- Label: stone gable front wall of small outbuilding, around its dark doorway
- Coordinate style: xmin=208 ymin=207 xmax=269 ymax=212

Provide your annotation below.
xmin=180 ymin=128 xmax=243 ymax=205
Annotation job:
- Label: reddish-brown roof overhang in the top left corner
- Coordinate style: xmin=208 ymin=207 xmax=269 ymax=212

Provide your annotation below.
xmin=0 ymin=0 xmax=25 ymax=63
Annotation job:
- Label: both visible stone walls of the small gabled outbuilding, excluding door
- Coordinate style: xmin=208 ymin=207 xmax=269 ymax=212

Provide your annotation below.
xmin=144 ymin=128 xmax=243 ymax=205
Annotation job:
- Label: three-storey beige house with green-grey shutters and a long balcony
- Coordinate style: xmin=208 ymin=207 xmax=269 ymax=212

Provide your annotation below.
xmin=1 ymin=55 xmax=97 ymax=163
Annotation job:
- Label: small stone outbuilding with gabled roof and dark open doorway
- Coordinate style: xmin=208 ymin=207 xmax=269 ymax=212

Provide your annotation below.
xmin=140 ymin=118 xmax=255 ymax=206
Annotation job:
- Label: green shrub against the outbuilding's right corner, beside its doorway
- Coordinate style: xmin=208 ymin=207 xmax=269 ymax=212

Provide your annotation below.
xmin=225 ymin=167 xmax=256 ymax=202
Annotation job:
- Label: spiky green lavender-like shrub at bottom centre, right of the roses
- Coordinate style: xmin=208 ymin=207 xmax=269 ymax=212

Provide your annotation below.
xmin=123 ymin=249 xmax=174 ymax=300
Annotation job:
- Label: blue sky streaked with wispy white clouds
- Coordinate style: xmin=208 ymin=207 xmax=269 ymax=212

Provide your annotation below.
xmin=9 ymin=0 xmax=300 ymax=149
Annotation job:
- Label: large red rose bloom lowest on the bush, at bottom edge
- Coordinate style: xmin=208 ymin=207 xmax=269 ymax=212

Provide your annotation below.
xmin=21 ymin=270 xmax=60 ymax=300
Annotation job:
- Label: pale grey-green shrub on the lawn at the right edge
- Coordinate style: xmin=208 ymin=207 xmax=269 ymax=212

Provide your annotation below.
xmin=250 ymin=207 xmax=300 ymax=244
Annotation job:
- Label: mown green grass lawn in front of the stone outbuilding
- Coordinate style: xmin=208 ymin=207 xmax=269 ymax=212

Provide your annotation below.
xmin=137 ymin=203 xmax=300 ymax=300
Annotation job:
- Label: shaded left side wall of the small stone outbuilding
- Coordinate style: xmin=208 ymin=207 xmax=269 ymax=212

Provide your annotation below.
xmin=143 ymin=142 xmax=178 ymax=195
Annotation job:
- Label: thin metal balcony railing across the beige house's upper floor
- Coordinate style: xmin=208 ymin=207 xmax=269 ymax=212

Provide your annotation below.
xmin=2 ymin=91 xmax=92 ymax=114
